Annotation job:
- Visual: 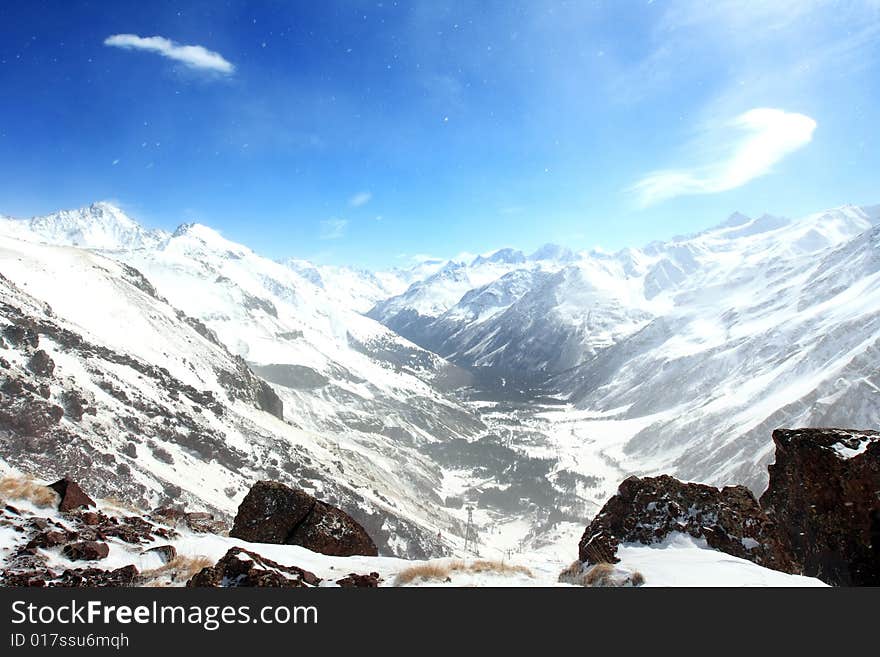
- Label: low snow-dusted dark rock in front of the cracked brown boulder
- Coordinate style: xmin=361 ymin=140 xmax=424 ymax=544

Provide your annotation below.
xmin=186 ymin=547 xmax=321 ymax=588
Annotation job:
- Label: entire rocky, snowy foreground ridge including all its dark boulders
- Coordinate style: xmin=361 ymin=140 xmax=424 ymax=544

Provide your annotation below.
xmin=0 ymin=429 xmax=880 ymax=587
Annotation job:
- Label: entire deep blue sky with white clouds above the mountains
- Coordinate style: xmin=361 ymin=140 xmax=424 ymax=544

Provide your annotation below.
xmin=0 ymin=0 xmax=880 ymax=267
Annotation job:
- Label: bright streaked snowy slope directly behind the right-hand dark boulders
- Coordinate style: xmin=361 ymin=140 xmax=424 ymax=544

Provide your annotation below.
xmin=554 ymin=207 xmax=880 ymax=491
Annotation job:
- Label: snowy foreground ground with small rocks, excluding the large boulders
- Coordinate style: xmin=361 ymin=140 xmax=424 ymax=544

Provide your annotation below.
xmin=0 ymin=486 xmax=822 ymax=587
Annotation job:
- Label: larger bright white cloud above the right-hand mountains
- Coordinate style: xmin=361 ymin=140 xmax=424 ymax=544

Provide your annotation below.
xmin=629 ymin=107 xmax=816 ymax=207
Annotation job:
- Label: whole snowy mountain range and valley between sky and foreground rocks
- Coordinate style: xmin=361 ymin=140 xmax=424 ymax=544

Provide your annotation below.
xmin=0 ymin=203 xmax=880 ymax=556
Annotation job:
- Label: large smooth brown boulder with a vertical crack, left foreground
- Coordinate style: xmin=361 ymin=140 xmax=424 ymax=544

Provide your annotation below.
xmin=229 ymin=481 xmax=378 ymax=557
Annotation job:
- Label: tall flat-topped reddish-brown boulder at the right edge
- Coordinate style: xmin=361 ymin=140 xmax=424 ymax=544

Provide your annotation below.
xmin=761 ymin=429 xmax=880 ymax=586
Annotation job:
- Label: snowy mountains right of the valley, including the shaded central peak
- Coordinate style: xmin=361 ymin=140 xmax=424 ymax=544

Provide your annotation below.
xmin=360 ymin=206 xmax=880 ymax=492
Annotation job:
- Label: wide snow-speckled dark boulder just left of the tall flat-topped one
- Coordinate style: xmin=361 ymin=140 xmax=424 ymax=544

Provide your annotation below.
xmin=579 ymin=475 xmax=798 ymax=573
